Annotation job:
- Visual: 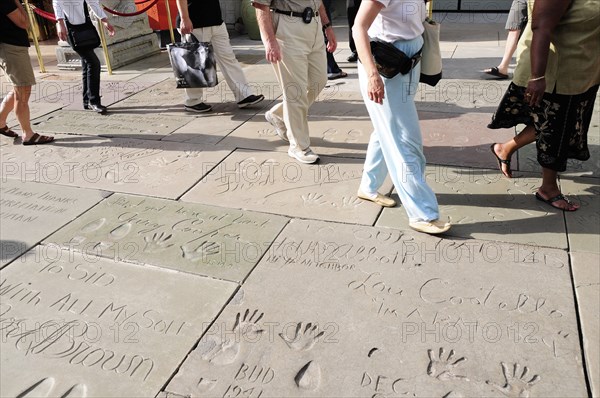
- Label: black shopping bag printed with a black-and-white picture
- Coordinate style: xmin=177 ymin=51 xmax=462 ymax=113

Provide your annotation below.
xmin=167 ymin=35 xmax=218 ymax=88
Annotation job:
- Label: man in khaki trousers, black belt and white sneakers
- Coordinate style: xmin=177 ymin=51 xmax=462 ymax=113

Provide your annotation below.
xmin=252 ymin=0 xmax=337 ymax=163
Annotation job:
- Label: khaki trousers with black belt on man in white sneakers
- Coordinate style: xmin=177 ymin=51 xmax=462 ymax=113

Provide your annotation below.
xmin=271 ymin=15 xmax=327 ymax=150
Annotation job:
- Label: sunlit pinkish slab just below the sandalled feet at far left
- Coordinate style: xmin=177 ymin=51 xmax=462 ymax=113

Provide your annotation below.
xmin=0 ymin=134 xmax=229 ymax=199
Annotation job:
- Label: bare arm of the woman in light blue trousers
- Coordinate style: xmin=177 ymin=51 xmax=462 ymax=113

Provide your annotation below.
xmin=352 ymin=0 xmax=384 ymax=104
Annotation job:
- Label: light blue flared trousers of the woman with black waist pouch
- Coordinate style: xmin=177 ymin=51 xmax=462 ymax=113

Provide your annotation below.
xmin=358 ymin=36 xmax=439 ymax=222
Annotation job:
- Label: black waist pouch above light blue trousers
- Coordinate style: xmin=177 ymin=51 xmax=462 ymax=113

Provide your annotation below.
xmin=371 ymin=41 xmax=421 ymax=79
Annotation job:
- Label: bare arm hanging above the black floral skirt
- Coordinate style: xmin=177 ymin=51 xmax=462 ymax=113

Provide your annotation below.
xmin=525 ymin=0 xmax=571 ymax=105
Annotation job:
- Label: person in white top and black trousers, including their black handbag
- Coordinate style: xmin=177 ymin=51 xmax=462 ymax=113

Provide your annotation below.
xmin=52 ymin=0 xmax=115 ymax=115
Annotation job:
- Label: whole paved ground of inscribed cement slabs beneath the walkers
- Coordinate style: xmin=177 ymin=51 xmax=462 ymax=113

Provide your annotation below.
xmin=0 ymin=14 xmax=600 ymax=398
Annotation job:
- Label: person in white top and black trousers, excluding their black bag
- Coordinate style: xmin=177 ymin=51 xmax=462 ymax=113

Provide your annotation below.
xmin=52 ymin=0 xmax=115 ymax=114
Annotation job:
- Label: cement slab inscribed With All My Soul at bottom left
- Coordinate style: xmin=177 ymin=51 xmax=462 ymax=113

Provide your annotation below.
xmin=0 ymin=246 xmax=236 ymax=397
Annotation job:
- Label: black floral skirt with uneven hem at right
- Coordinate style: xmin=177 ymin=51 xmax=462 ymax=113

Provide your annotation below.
xmin=488 ymin=83 xmax=598 ymax=171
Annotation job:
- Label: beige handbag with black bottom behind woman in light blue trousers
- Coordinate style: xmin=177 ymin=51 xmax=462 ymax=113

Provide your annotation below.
xmin=419 ymin=18 xmax=442 ymax=86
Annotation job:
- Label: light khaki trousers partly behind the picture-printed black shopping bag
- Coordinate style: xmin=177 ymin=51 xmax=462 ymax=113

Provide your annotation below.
xmin=185 ymin=23 xmax=252 ymax=106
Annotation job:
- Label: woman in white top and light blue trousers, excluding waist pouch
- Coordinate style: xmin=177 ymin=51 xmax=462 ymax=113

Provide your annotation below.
xmin=352 ymin=0 xmax=450 ymax=234
